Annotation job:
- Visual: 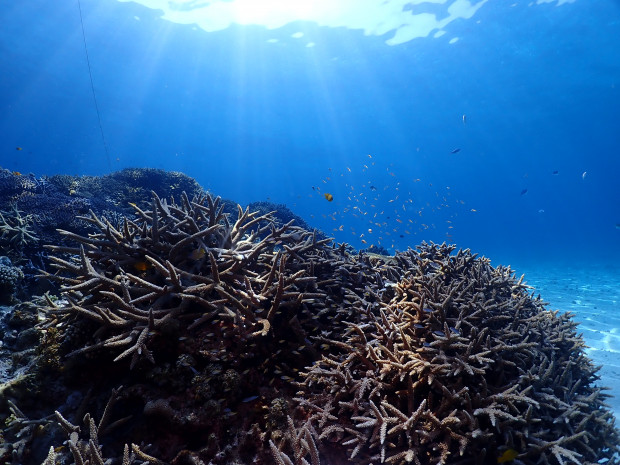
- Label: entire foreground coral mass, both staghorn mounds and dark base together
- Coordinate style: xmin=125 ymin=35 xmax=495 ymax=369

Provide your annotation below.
xmin=0 ymin=169 xmax=620 ymax=465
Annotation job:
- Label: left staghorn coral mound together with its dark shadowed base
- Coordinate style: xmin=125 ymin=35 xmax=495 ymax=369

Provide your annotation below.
xmin=31 ymin=190 xmax=400 ymax=457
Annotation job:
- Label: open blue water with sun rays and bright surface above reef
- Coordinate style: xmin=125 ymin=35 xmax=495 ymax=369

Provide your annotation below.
xmin=0 ymin=0 xmax=620 ymax=265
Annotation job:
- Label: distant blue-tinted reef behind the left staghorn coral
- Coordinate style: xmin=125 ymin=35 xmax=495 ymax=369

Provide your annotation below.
xmin=0 ymin=169 xmax=220 ymax=267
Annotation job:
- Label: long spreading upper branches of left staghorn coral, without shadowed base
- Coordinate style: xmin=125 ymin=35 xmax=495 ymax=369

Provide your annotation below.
xmin=40 ymin=190 xmax=340 ymax=366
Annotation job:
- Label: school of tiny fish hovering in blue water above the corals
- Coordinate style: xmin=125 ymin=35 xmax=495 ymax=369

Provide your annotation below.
xmin=309 ymin=154 xmax=464 ymax=250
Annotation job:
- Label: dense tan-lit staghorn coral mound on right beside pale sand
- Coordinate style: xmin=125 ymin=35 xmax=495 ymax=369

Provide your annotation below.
xmin=296 ymin=245 xmax=618 ymax=465
